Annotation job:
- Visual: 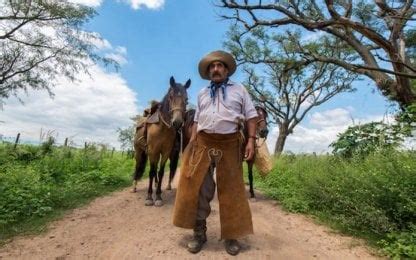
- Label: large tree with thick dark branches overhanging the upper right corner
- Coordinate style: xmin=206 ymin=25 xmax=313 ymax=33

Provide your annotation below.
xmin=217 ymin=0 xmax=416 ymax=108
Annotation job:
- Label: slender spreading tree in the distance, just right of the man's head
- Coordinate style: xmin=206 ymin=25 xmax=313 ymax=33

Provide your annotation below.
xmin=225 ymin=27 xmax=357 ymax=155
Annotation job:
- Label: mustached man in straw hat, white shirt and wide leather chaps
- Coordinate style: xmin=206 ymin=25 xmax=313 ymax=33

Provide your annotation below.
xmin=173 ymin=51 xmax=257 ymax=255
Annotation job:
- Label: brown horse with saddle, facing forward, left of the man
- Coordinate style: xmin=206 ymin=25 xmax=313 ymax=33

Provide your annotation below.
xmin=134 ymin=77 xmax=191 ymax=206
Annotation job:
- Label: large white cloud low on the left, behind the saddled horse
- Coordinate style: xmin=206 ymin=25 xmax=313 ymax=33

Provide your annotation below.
xmin=0 ymin=65 xmax=138 ymax=147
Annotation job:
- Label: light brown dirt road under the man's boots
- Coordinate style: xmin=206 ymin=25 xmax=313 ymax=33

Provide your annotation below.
xmin=0 ymin=178 xmax=376 ymax=259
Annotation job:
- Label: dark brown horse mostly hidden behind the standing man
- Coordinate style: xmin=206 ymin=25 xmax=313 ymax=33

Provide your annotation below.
xmin=168 ymin=106 xmax=269 ymax=198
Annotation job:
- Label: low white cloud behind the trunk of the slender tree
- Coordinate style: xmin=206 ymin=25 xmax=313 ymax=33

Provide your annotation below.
xmin=267 ymin=107 xmax=393 ymax=154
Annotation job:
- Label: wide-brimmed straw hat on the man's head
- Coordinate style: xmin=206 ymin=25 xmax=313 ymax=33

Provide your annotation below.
xmin=198 ymin=51 xmax=237 ymax=80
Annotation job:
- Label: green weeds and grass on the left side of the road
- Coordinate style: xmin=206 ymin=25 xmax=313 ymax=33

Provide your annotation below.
xmin=0 ymin=144 xmax=133 ymax=240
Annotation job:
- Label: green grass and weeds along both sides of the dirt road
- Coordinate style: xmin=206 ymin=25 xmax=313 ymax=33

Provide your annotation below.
xmin=0 ymin=144 xmax=416 ymax=258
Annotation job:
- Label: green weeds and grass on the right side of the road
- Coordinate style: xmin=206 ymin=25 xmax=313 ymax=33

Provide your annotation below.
xmin=255 ymin=150 xmax=416 ymax=258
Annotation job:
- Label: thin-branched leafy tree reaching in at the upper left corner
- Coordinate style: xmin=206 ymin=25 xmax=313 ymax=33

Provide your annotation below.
xmin=0 ymin=0 xmax=113 ymax=99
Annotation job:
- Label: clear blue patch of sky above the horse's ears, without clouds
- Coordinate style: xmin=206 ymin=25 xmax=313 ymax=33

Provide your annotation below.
xmin=88 ymin=0 xmax=228 ymax=106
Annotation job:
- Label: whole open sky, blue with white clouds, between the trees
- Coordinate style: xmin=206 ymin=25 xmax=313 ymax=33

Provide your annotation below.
xmin=0 ymin=0 xmax=400 ymax=153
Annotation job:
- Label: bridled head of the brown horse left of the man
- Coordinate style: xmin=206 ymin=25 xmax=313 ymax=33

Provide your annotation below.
xmin=168 ymin=77 xmax=191 ymax=129
